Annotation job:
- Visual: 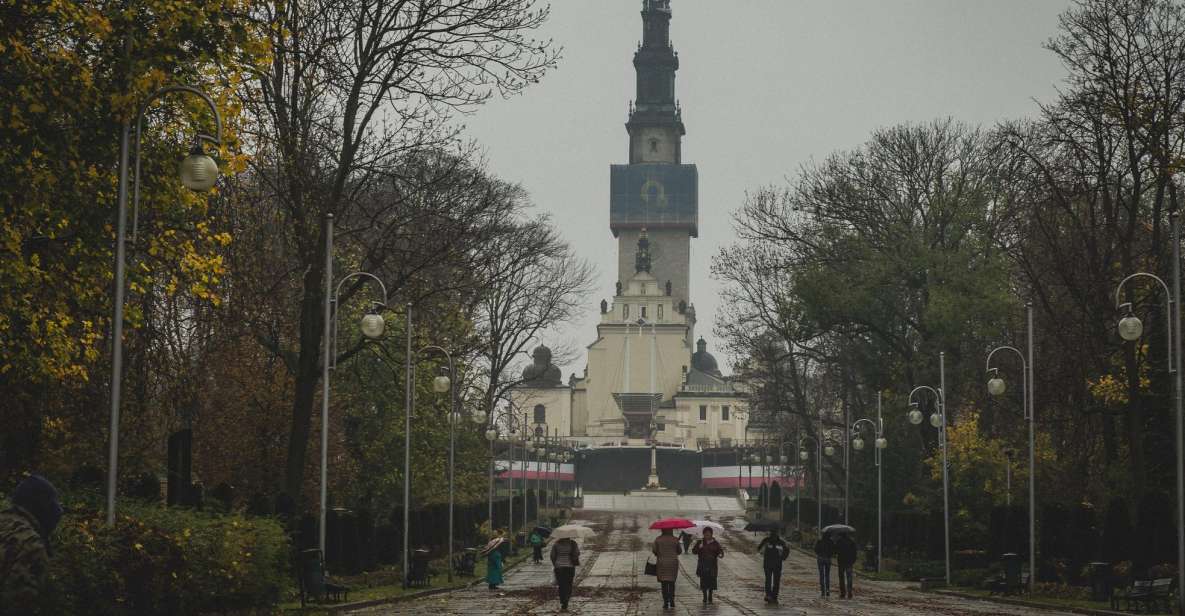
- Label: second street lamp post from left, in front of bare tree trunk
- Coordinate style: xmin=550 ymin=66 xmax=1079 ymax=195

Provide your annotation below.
xmin=316 ymin=266 xmax=387 ymax=558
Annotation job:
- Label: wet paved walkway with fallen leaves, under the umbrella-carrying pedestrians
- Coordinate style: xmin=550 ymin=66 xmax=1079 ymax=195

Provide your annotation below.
xmin=353 ymin=511 xmax=1085 ymax=616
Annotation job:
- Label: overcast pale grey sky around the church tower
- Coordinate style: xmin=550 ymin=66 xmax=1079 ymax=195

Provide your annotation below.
xmin=465 ymin=0 xmax=1070 ymax=380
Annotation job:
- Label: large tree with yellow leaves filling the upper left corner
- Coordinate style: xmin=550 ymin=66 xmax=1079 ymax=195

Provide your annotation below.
xmin=0 ymin=0 xmax=265 ymax=473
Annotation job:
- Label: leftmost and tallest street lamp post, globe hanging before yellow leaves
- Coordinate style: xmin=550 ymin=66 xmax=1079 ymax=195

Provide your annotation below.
xmin=107 ymin=85 xmax=222 ymax=526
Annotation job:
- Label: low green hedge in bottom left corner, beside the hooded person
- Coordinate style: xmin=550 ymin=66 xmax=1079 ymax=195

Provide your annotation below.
xmin=26 ymin=501 xmax=293 ymax=615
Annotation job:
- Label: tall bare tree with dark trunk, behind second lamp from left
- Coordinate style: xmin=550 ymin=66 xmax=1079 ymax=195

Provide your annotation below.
xmin=243 ymin=0 xmax=558 ymax=499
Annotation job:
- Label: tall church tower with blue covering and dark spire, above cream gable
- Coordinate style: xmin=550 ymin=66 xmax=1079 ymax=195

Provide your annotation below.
xmin=609 ymin=0 xmax=699 ymax=303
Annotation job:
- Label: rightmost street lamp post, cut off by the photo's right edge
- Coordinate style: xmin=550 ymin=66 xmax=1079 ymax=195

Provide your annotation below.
xmin=1109 ymin=232 xmax=1185 ymax=614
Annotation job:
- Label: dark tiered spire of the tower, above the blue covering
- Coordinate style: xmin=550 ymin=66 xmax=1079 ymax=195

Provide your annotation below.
xmin=626 ymin=0 xmax=686 ymax=165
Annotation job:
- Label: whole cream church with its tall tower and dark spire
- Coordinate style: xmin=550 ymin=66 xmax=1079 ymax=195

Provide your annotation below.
xmin=512 ymin=0 xmax=786 ymax=489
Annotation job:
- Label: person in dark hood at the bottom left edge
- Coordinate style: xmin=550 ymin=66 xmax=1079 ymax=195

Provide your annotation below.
xmin=0 ymin=475 xmax=62 ymax=614
